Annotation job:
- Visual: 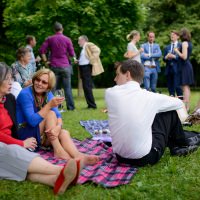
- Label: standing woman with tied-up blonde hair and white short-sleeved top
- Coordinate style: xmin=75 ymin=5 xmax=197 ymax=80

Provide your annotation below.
xmin=124 ymin=30 xmax=144 ymax=63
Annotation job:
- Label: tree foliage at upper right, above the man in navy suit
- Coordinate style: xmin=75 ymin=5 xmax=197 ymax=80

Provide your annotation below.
xmin=145 ymin=0 xmax=200 ymax=63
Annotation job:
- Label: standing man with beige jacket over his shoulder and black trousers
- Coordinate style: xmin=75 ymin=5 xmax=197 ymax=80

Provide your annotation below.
xmin=78 ymin=35 xmax=103 ymax=109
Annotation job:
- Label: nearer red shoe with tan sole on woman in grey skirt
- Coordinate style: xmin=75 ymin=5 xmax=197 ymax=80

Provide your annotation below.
xmin=53 ymin=159 xmax=77 ymax=195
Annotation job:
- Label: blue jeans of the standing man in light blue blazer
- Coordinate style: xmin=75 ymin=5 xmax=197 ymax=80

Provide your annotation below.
xmin=144 ymin=67 xmax=158 ymax=92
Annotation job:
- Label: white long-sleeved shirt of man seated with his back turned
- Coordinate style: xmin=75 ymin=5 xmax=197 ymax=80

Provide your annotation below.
xmin=105 ymin=81 xmax=183 ymax=159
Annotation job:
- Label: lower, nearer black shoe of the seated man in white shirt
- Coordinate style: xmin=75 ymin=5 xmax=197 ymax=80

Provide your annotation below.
xmin=170 ymin=145 xmax=198 ymax=156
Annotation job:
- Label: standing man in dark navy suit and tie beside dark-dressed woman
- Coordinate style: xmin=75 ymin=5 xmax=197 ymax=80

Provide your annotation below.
xmin=163 ymin=30 xmax=183 ymax=99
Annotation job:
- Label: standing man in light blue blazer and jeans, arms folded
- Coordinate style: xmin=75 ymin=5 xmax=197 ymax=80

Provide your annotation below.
xmin=141 ymin=31 xmax=162 ymax=92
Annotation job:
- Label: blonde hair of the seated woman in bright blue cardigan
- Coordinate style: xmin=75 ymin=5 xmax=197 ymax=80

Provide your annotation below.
xmin=32 ymin=68 xmax=56 ymax=91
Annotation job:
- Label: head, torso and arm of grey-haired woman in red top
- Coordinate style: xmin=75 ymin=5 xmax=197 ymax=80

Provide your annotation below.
xmin=0 ymin=62 xmax=37 ymax=149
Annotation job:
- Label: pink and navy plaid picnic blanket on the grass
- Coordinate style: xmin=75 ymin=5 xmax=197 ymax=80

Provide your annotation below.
xmin=38 ymin=139 xmax=137 ymax=188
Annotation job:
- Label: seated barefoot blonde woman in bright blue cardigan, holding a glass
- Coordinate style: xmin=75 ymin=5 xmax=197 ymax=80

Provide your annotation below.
xmin=17 ymin=69 xmax=98 ymax=164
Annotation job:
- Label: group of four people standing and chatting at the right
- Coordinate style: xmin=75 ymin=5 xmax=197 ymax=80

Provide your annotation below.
xmin=124 ymin=28 xmax=194 ymax=110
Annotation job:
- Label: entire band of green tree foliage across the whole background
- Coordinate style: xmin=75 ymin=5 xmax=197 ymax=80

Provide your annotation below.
xmin=0 ymin=0 xmax=200 ymax=87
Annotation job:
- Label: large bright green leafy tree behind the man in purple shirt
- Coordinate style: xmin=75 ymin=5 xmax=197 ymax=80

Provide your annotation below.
xmin=3 ymin=0 xmax=145 ymax=86
